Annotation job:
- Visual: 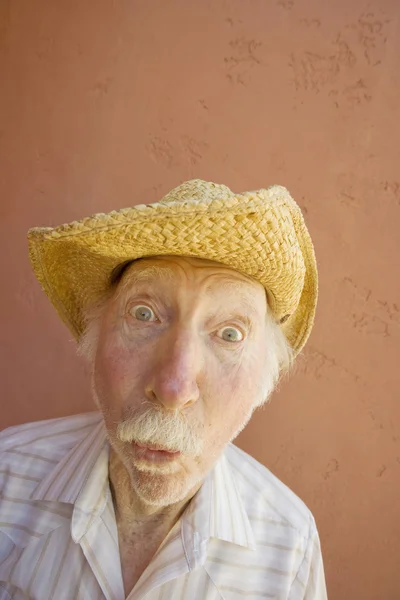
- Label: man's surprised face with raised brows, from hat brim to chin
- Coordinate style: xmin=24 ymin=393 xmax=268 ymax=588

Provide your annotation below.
xmin=93 ymin=257 xmax=268 ymax=506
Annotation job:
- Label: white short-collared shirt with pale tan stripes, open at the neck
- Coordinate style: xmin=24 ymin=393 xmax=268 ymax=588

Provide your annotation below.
xmin=0 ymin=413 xmax=326 ymax=600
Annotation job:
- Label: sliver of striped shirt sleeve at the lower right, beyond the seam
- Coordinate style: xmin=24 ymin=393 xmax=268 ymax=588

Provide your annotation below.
xmin=288 ymin=524 xmax=328 ymax=600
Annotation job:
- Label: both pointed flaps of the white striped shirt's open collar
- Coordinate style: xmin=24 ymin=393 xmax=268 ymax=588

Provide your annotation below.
xmin=31 ymin=415 xmax=256 ymax=562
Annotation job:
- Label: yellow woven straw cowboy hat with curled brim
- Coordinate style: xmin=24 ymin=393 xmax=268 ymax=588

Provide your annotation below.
xmin=28 ymin=179 xmax=318 ymax=353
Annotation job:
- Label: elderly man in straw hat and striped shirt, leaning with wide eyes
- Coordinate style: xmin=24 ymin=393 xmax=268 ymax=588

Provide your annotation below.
xmin=0 ymin=180 xmax=326 ymax=600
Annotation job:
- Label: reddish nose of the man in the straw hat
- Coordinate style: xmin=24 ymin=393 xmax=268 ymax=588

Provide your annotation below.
xmin=145 ymin=333 xmax=201 ymax=410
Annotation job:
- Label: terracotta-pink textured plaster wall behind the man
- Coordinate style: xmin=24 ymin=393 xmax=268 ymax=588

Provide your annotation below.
xmin=0 ymin=0 xmax=400 ymax=600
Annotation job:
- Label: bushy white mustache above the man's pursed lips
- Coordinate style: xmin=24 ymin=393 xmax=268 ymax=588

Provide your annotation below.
xmin=116 ymin=402 xmax=203 ymax=456
